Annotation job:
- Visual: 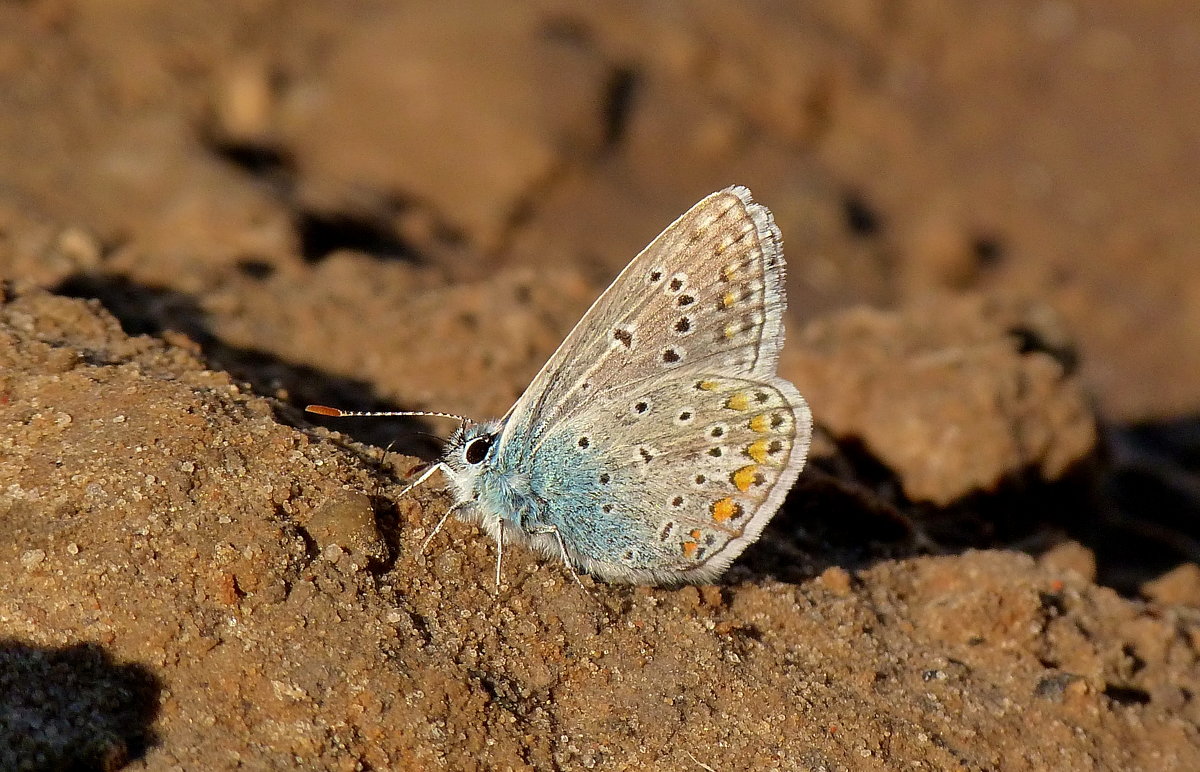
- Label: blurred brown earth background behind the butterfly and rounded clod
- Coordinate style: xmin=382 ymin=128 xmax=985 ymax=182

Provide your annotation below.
xmin=0 ymin=0 xmax=1200 ymax=590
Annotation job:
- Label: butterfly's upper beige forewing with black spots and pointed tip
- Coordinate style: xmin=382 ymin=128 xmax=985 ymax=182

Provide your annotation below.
xmin=500 ymin=187 xmax=785 ymax=445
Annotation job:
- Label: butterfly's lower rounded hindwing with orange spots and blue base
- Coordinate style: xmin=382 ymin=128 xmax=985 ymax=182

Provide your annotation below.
xmin=530 ymin=373 xmax=811 ymax=582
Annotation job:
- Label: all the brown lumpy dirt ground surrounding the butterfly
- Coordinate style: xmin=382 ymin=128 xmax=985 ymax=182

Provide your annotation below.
xmin=0 ymin=0 xmax=1200 ymax=772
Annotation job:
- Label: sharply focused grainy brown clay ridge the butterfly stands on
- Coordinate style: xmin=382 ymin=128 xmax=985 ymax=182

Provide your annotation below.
xmin=0 ymin=288 xmax=1200 ymax=770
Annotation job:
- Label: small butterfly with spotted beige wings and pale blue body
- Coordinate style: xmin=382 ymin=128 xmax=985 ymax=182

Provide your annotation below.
xmin=307 ymin=186 xmax=812 ymax=585
